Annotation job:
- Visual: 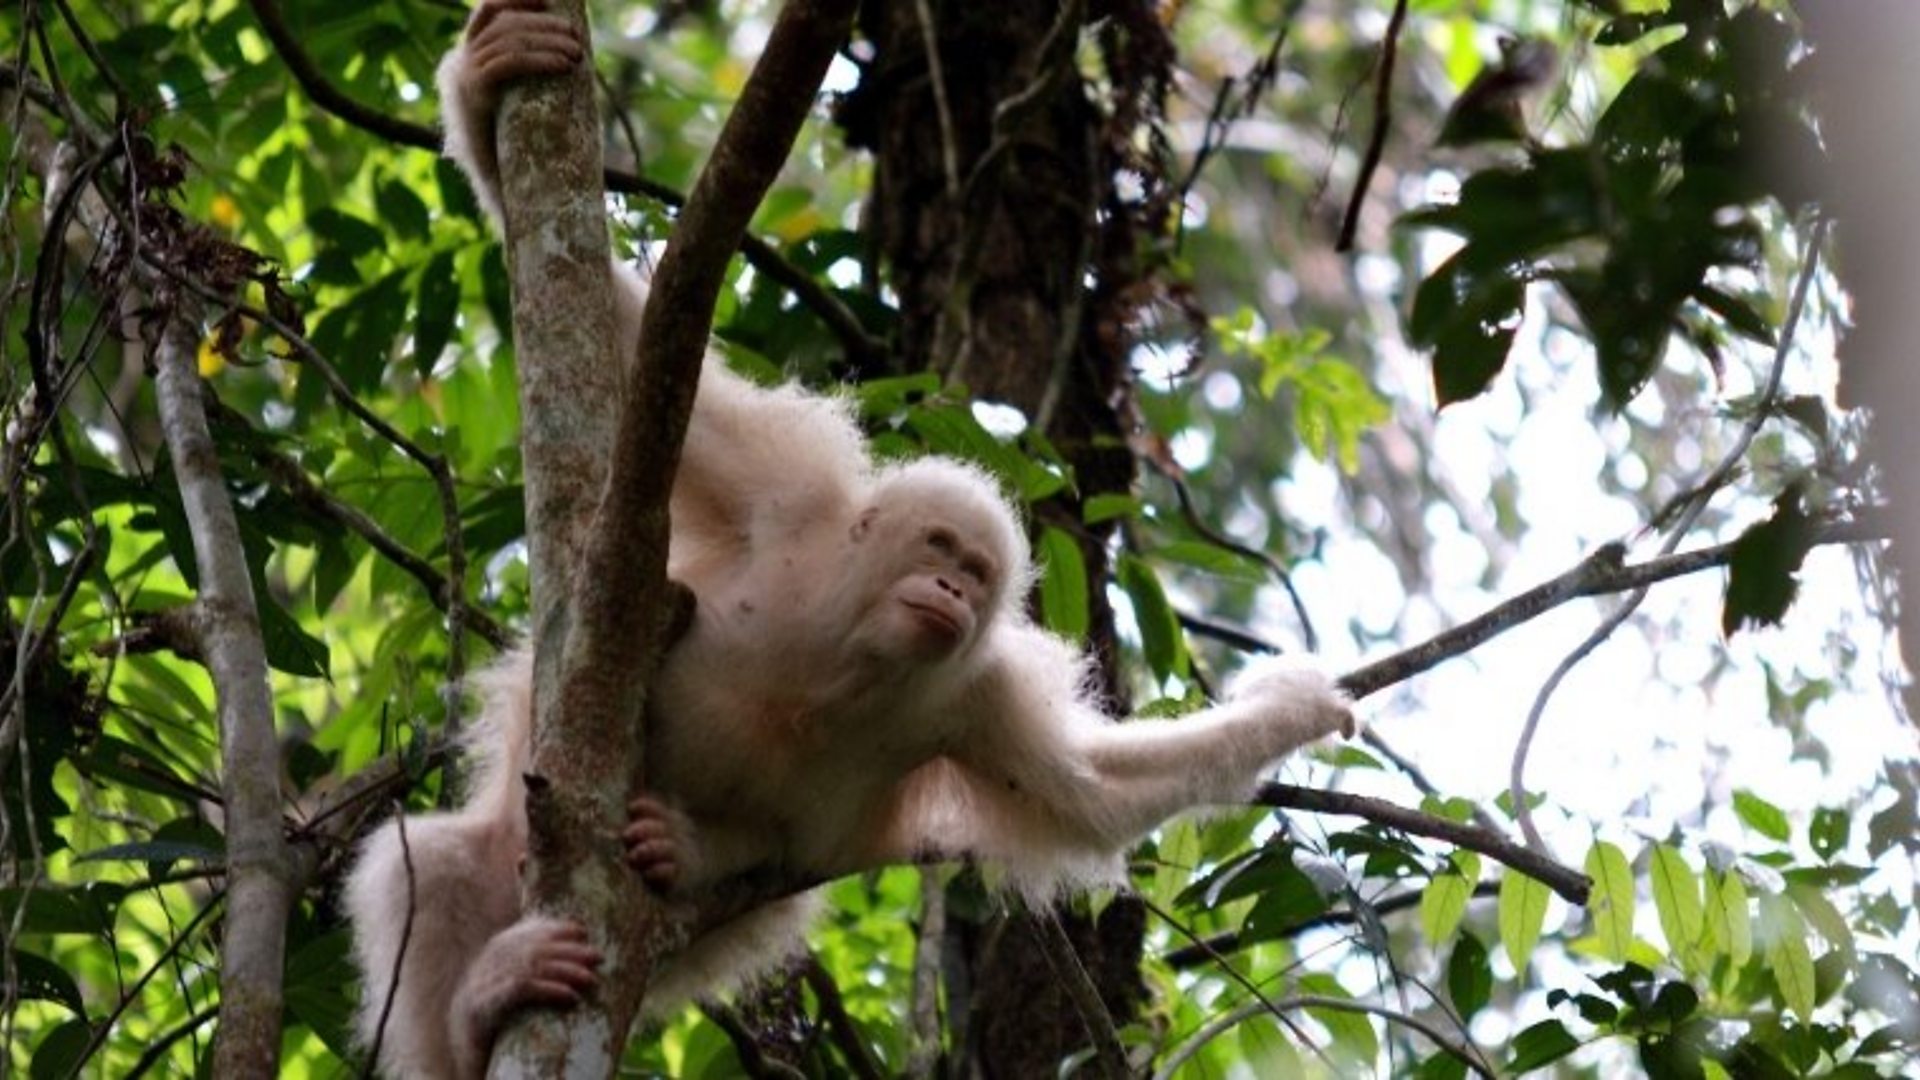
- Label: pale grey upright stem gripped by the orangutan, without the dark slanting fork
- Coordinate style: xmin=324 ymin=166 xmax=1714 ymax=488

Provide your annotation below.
xmin=490 ymin=0 xmax=629 ymax=1076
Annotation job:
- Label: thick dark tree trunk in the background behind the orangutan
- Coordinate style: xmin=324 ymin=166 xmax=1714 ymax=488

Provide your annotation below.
xmin=841 ymin=0 xmax=1171 ymax=1076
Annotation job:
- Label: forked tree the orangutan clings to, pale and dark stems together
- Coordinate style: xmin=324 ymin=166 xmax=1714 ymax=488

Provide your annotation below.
xmin=490 ymin=0 xmax=854 ymax=1076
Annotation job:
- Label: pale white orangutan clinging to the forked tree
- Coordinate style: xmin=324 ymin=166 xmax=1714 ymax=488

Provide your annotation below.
xmin=348 ymin=0 xmax=1354 ymax=1078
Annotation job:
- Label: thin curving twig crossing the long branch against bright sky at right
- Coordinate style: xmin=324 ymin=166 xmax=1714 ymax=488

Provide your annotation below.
xmin=1507 ymin=219 xmax=1826 ymax=855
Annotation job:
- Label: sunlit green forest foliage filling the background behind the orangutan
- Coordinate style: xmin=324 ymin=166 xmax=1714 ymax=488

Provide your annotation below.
xmin=0 ymin=0 xmax=1920 ymax=1078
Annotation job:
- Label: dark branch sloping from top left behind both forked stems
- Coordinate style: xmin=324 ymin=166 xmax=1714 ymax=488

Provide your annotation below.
xmin=248 ymin=0 xmax=887 ymax=363
